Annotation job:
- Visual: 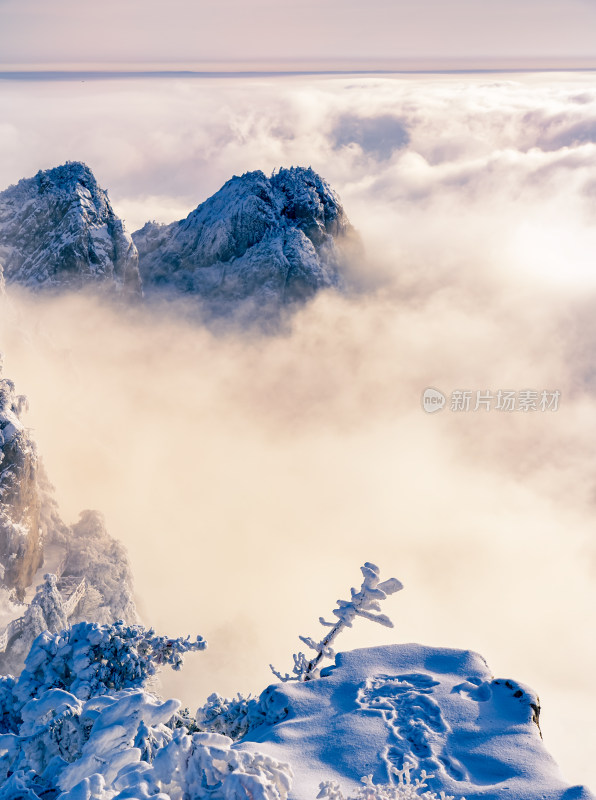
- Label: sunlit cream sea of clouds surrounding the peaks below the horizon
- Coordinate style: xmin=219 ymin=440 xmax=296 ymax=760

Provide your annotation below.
xmin=0 ymin=73 xmax=596 ymax=785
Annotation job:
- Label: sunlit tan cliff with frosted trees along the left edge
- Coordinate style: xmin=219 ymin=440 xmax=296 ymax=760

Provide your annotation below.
xmin=0 ymin=360 xmax=137 ymax=673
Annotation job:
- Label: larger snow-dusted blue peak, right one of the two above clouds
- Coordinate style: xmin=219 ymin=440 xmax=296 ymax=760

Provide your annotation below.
xmin=133 ymin=167 xmax=355 ymax=314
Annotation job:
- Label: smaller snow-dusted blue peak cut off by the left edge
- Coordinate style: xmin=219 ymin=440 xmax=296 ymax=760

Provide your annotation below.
xmin=0 ymin=162 xmax=141 ymax=295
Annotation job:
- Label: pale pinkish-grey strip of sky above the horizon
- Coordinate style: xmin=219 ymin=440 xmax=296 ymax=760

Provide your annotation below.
xmin=0 ymin=0 xmax=596 ymax=66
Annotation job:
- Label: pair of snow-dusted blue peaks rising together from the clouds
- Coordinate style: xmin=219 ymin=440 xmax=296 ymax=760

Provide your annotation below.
xmin=0 ymin=162 xmax=357 ymax=321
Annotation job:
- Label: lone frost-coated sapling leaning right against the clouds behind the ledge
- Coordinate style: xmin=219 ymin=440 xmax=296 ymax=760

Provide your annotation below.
xmin=269 ymin=561 xmax=404 ymax=682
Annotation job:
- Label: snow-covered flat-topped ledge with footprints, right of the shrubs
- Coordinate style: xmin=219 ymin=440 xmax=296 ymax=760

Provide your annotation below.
xmin=237 ymin=644 xmax=594 ymax=800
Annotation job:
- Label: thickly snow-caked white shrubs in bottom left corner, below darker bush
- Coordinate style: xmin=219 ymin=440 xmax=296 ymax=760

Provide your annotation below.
xmin=0 ymin=689 xmax=292 ymax=800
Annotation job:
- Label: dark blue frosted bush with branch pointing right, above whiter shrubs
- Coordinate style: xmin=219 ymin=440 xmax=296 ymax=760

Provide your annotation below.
xmin=15 ymin=621 xmax=207 ymax=703
